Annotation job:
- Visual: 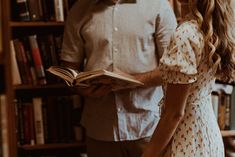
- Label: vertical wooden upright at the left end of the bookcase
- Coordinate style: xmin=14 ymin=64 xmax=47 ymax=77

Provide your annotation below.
xmin=0 ymin=0 xmax=18 ymax=157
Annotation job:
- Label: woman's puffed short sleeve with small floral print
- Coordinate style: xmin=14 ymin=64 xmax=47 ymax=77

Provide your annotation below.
xmin=159 ymin=21 xmax=203 ymax=84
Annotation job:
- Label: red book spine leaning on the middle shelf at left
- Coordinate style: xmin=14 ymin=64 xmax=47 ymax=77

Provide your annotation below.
xmin=29 ymin=35 xmax=46 ymax=84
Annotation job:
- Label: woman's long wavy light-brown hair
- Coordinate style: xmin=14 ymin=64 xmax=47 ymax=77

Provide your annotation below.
xmin=189 ymin=0 xmax=235 ymax=81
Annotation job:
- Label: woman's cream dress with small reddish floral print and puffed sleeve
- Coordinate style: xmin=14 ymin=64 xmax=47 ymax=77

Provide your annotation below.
xmin=160 ymin=20 xmax=224 ymax=157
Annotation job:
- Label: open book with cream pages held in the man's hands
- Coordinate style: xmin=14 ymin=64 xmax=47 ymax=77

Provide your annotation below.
xmin=47 ymin=66 xmax=143 ymax=91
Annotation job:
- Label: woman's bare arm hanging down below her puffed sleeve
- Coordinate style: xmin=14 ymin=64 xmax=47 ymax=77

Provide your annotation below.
xmin=142 ymin=84 xmax=190 ymax=157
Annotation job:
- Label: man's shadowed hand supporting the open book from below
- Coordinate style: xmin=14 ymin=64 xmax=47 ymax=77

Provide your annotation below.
xmin=76 ymin=85 xmax=112 ymax=98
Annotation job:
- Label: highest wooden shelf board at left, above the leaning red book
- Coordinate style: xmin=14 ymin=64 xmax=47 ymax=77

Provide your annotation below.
xmin=10 ymin=21 xmax=64 ymax=27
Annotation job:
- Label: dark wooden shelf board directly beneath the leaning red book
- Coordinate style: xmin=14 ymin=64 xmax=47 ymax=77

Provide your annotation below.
xmin=14 ymin=83 xmax=76 ymax=97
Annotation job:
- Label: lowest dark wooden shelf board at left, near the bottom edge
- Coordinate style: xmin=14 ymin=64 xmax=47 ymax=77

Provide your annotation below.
xmin=19 ymin=142 xmax=86 ymax=150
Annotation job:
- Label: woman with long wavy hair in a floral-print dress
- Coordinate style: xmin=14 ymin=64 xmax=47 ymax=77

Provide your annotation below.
xmin=142 ymin=0 xmax=235 ymax=157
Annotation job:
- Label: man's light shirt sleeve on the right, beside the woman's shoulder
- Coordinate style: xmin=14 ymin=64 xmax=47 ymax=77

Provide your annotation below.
xmin=155 ymin=0 xmax=177 ymax=57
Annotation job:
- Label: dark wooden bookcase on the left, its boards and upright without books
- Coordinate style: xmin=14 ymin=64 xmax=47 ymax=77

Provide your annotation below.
xmin=0 ymin=0 xmax=85 ymax=157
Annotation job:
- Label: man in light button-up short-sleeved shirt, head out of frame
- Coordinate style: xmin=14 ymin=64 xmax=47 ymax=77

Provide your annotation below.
xmin=61 ymin=0 xmax=176 ymax=157
